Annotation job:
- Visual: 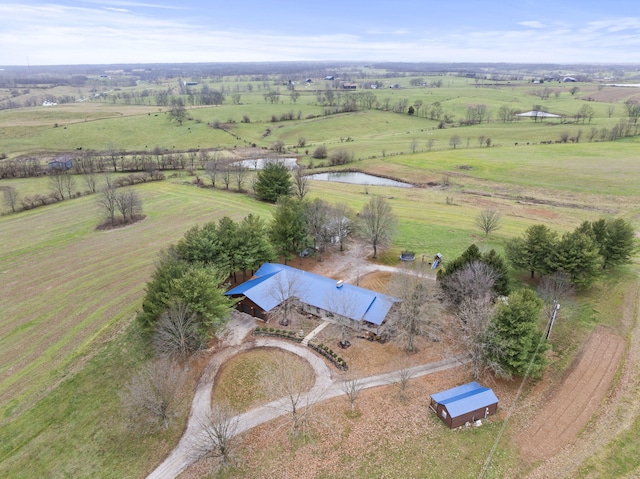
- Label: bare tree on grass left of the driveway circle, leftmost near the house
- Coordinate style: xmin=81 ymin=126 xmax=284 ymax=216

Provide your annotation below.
xmin=120 ymin=360 xmax=185 ymax=429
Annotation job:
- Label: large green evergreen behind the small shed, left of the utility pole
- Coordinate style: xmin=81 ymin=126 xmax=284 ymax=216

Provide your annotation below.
xmin=488 ymin=289 xmax=548 ymax=378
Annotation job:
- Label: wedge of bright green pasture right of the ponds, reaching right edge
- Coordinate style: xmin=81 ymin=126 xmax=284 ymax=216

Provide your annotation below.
xmin=378 ymin=141 xmax=640 ymax=197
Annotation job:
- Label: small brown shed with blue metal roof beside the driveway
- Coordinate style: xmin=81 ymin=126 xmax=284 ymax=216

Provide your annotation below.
xmin=430 ymin=381 xmax=498 ymax=429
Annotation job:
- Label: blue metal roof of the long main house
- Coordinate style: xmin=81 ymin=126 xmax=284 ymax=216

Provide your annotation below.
xmin=226 ymin=263 xmax=398 ymax=325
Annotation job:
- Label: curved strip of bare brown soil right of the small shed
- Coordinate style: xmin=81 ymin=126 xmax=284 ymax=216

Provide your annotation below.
xmin=518 ymin=329 xmax=625 ymax=461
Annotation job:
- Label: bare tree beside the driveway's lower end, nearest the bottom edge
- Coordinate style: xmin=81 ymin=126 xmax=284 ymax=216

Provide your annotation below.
xmin=191 ymin=404 xmax=240 ymax=466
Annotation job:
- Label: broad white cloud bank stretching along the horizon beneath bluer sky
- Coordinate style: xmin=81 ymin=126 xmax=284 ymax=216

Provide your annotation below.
xmin=0 ymin=0 xmax=640 ymax=65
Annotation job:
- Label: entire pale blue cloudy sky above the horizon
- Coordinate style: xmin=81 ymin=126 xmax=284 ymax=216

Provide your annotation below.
xmin=0 ymin=0 xmax=640 ymax=65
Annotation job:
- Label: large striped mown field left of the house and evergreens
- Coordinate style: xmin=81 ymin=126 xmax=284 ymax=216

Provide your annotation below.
xmin=0 ymin=181 xmax=271 ymax=421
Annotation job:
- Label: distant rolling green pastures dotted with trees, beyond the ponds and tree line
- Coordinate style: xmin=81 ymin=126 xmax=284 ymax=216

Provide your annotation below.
xmin=0 ymin=76 xmax=635 ymax=159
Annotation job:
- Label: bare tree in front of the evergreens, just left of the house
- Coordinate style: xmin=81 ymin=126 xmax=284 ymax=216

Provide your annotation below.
xmin=153 ymin=301 xmax=206 ymax=363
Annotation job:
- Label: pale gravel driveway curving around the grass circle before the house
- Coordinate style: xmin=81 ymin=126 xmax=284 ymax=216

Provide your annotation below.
xmin=147 ymin=315 xmax=463 ymax=479
